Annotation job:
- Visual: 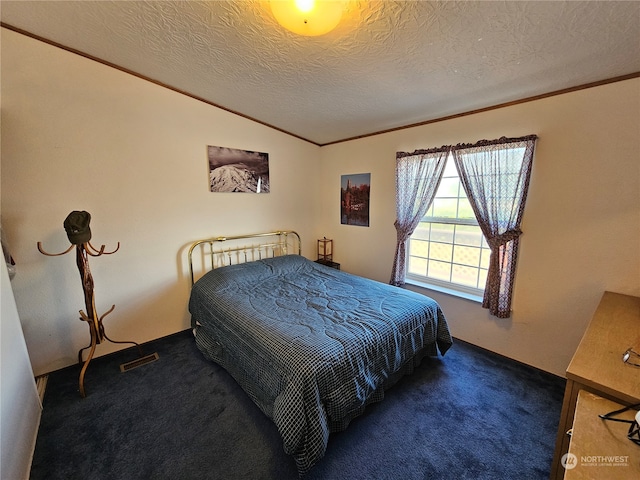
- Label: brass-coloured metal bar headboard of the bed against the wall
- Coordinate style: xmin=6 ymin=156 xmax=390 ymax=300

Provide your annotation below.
xmin=188 ymin=230 xmax=302 ymax=286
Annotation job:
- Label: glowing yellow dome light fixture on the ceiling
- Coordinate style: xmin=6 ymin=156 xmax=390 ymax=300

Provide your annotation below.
xmin=271 ymin=0 xmax=342 ymax=37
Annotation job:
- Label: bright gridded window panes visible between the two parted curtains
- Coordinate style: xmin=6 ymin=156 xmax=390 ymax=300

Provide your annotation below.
xmin=406 ymin=153 xmax=491 ymax=296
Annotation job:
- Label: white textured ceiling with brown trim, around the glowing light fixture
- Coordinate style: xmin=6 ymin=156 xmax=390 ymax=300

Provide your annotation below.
xmin=0 ymin=0 xmax=640 ymax=145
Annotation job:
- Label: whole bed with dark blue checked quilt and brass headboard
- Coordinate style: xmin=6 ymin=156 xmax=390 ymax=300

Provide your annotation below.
xmin=189 ymin=231 xmax=452 ymax=476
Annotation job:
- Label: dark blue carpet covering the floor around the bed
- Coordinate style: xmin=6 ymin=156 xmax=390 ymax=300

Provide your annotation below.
xmin=31 ymin=331 xmax=565 ymax=480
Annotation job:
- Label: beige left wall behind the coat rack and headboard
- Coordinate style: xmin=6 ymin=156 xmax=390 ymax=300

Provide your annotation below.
xmin=1 ymin=29 xmax=319 ymax=374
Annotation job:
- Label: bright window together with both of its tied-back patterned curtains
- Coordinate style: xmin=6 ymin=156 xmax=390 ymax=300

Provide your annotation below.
xmin=389 ymin=135 xmax=538 ymax=318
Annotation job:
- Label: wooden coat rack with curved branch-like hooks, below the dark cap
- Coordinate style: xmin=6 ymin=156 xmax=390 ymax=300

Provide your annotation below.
xmin=38 ymin=219 xmax=142 ymax=397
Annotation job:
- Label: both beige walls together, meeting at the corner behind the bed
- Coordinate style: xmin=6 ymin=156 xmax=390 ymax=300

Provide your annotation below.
xmin=2 ymin=29 xmax=640 ymax=375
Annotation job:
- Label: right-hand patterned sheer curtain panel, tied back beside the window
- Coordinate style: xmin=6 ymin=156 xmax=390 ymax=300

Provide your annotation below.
xmin=452 ymin=135 xmax=537 ymax=318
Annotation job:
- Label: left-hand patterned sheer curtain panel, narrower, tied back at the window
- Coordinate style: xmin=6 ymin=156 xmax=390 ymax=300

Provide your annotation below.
xmin=389 ymin=146 xmax=451 ymax=286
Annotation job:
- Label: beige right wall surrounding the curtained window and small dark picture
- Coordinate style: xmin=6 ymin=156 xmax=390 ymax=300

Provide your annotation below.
xmin=321 ymin=79 xmax=640 ymax=375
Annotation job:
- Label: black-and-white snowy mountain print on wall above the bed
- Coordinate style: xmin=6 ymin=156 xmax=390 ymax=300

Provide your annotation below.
xmin=207 ymin=145 xmax=269 ymax=193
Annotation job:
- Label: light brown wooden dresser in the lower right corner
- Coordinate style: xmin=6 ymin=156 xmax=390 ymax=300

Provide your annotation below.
xmin=551 ymin=292 xmax=640 ymax=480
